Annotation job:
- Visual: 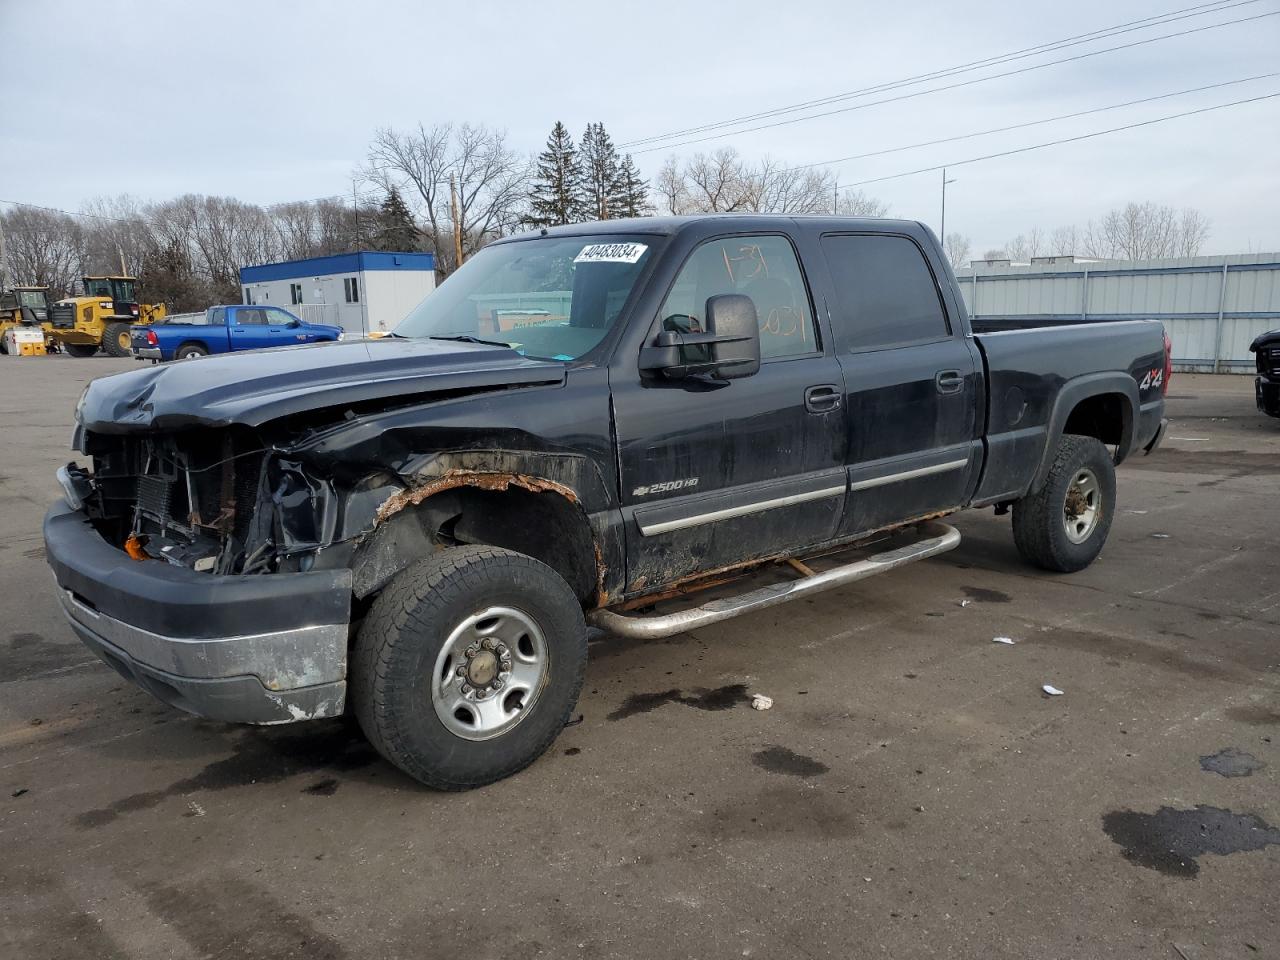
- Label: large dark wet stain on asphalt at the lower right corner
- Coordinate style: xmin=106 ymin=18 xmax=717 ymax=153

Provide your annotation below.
xmin=1102 ymin=804 xmax=1280 ymax=877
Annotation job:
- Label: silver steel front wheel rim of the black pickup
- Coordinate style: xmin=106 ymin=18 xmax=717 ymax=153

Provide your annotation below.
xmin=429 ymin=607 xmax=550 ymax=740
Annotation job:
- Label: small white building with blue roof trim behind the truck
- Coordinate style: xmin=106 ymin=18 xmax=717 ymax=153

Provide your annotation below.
xmin=241 ymin=251 xmax=435 ymax=334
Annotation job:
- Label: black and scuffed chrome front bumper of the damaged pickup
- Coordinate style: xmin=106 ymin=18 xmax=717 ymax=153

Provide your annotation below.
xmin=45 ymin=503 xmax=351 ymax=723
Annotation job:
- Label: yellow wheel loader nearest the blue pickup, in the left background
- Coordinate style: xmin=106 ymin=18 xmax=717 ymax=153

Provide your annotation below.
xmin=47 ymin=276 xmax=165 ymax=357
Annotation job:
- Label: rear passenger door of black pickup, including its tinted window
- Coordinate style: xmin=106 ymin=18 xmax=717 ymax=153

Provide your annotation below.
xmin=819 ymin=233 xmax=983 ymax=535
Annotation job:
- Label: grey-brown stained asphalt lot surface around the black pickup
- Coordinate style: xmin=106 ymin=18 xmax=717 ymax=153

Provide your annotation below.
xmin=0 ymin=357 xmax=1280 ymax=960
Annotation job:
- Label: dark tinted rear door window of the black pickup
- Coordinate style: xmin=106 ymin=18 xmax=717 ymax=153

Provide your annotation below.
xmin=822 ymin=234 xmax=951 ymax=353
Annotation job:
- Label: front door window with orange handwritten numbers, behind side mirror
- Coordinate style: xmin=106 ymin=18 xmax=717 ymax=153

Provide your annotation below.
xmin=659 ymin=237 xmax=819 ymax=360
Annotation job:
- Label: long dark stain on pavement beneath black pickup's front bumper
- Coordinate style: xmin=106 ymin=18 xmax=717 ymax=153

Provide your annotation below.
xmin=76 ymin=719 xmax=379 ymax=829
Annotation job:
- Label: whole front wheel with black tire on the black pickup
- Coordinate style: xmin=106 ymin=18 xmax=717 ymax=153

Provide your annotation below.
xmin=351 ymin=547 xmax=586 ymax=790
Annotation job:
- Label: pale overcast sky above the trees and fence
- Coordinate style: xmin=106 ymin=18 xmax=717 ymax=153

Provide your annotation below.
xmin=0 ymin=0 xmax=1280 ymax=252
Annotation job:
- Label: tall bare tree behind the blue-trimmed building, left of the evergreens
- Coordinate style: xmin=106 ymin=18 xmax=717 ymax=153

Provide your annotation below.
xmin=366 ymin=123 xmax=530 ymax=273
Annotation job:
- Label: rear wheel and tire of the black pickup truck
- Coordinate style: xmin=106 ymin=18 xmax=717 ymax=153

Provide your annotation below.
xmin=1014 ymin=434 xmax=1116 ymax=573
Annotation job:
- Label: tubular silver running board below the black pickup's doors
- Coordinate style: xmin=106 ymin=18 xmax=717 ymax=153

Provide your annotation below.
xmin=588 ymin=521 xmax=960 ymax=640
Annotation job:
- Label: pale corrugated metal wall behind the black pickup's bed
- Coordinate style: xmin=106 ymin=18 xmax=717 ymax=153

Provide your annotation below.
xmin=956 ymin=253 xmax=1280 ymax=372
